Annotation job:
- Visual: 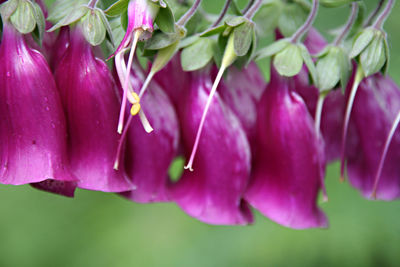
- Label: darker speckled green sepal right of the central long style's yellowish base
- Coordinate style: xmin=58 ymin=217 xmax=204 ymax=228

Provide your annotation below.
xmin=233 ymin=21 xmax=254 ymax=57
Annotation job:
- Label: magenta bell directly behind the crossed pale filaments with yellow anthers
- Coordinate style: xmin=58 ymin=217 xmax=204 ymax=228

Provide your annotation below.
xmin=121 ymin=66 xmax=179 ymax=203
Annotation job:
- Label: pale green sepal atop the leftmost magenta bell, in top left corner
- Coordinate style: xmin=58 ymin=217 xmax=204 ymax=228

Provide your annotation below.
xmin=10 ymin=1 xmax=36 ymax=34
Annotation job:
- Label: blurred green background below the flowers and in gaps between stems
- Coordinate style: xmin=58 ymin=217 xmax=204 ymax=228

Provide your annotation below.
xmin=0 ymin=0 xmax=400 ymax=266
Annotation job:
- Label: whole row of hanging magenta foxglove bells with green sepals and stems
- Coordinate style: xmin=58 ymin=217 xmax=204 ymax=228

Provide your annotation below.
xmin=0 ymin=0 xmax=400 ymax=229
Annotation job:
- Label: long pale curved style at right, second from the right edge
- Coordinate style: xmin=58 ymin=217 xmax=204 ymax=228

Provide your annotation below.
xmin=340 ymin=66 xmax=364 ymax=182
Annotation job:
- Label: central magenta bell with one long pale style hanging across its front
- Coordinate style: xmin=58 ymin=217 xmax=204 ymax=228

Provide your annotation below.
xmin=171 ymin=70 xmax=253 ymax=225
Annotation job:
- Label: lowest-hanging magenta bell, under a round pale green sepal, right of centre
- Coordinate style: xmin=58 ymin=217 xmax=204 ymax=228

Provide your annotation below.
xmin=245 ymin=67 xmax=327 ymax=229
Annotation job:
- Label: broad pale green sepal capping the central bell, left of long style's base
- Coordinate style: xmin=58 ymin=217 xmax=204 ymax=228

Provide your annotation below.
xmin=181 ymin=38 xmax=215 ymax=71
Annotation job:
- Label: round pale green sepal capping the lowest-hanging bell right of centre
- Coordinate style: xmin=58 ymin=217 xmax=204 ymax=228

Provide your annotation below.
xmin=273 ymin=44 xmax=303 ymax=77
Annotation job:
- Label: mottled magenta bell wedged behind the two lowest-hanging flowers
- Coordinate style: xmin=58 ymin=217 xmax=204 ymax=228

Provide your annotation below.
xmin=218 ymin=62 xmax=267 ymax=151
